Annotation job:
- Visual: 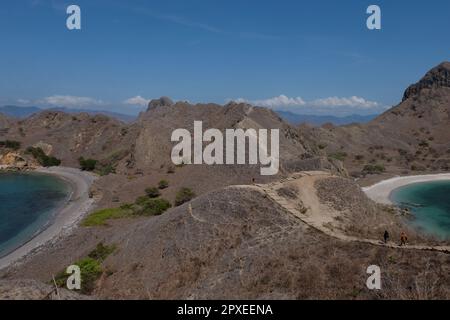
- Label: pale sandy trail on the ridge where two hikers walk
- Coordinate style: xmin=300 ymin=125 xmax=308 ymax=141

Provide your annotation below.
xmin=250 ymin=171 xmax=450 ymax=253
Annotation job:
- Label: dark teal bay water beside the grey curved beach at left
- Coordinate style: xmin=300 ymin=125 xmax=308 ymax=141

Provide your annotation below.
xmin=0 ymin=173 xmax=70 ymax=257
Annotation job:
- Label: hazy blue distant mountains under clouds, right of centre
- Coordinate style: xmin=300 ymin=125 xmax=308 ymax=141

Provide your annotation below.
xmin=277 ymin=111 xmax=378 ymax=126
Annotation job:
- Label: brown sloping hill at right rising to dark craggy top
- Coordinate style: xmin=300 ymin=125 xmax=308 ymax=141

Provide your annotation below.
xmin=303 ymin=62 xmax=450 ymax=175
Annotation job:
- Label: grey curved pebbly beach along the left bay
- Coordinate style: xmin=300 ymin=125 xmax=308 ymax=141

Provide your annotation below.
xmin=0 ymin=167 xmax=95 ymax=269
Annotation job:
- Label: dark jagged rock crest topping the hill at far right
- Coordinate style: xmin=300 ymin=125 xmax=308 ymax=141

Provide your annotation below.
xmin=403 ymin=61 xmax=450 ymax=101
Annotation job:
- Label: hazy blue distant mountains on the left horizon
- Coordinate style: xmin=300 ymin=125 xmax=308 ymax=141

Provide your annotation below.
xmin=0 ymin=106 xmax=137 ymax=122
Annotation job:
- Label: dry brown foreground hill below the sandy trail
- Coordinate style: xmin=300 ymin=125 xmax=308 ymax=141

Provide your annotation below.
xmin=0 ymin=173 xmax=450 ymax=299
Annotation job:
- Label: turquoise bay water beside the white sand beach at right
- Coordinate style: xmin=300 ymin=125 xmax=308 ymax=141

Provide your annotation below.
xmin=391 ymin=181 xmax=450 ymax=239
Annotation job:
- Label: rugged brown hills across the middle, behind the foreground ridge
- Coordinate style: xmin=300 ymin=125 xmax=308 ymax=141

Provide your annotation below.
xmin=0 ymin=97 xmax=346 ymax=214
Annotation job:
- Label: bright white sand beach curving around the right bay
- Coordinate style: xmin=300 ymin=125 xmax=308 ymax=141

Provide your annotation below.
xmin=362 ymin=173 xmax=450 ymax=204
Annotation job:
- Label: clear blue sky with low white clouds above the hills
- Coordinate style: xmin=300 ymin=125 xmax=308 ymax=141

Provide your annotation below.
xmin=0 ymin=0 xmax=450 ymax=115
